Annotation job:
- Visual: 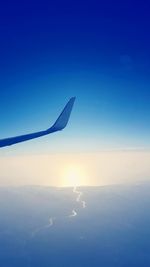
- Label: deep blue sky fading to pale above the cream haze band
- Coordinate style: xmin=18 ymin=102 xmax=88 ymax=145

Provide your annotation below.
xmin=0 ymin=0 xmax=150 ymax=155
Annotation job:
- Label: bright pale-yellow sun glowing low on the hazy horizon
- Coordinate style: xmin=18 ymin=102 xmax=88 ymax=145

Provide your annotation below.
xmin=61 ymin=165 xmax=87 ymax=187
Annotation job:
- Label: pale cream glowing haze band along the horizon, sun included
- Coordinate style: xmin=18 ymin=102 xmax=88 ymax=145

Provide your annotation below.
xmin=0 ymin=151 xmax=150 ymax=186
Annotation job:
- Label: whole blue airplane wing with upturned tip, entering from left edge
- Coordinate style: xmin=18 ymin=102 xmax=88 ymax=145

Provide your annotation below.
xmin=0 ymin=97 xmax=75 ymax=147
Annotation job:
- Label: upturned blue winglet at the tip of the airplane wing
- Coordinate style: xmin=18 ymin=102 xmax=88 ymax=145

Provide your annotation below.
xmin=47 ymin=97 xmax=75 ymax=133
